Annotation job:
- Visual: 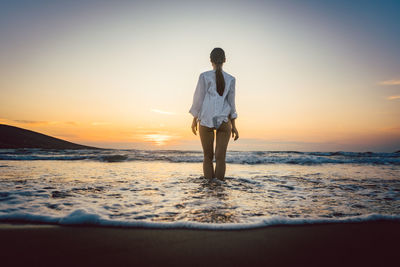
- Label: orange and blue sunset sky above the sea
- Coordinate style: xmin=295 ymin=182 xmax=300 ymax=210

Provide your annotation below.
xmin=0 ymin=0 xmax=400 ymax=152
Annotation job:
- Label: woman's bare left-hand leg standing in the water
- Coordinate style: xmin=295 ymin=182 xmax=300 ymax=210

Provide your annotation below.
xmin=199 ymin=125 xmax=215 ymax=179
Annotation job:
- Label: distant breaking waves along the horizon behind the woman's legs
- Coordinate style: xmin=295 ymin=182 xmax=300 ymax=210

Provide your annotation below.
xmin=0 ymin=149 xmax=400 ymax=165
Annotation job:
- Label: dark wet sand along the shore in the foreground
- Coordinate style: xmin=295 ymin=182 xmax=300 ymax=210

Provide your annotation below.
xmin=0 ymin=222 xmax=400 ymax=266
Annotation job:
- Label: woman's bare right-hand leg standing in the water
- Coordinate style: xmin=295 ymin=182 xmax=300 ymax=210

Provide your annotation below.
xmin=215 ymin=121 xmax=232 ymax=180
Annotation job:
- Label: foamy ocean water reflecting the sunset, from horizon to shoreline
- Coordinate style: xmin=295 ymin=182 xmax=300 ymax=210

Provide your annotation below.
xmin=0 ymin=149 xmax=400 ymax=229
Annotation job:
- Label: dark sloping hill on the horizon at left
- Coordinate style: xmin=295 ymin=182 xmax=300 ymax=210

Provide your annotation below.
xmin=0 ymin=124 xmax=98 ymax=149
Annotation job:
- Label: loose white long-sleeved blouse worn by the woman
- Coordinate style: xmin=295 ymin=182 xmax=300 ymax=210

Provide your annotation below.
xmin=189 ymin=70 xmax=237 ymax=129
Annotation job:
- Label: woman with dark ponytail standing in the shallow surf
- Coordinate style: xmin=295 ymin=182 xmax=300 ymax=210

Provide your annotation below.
xmin=189 ymin=47 xmax=239 ymax=180
